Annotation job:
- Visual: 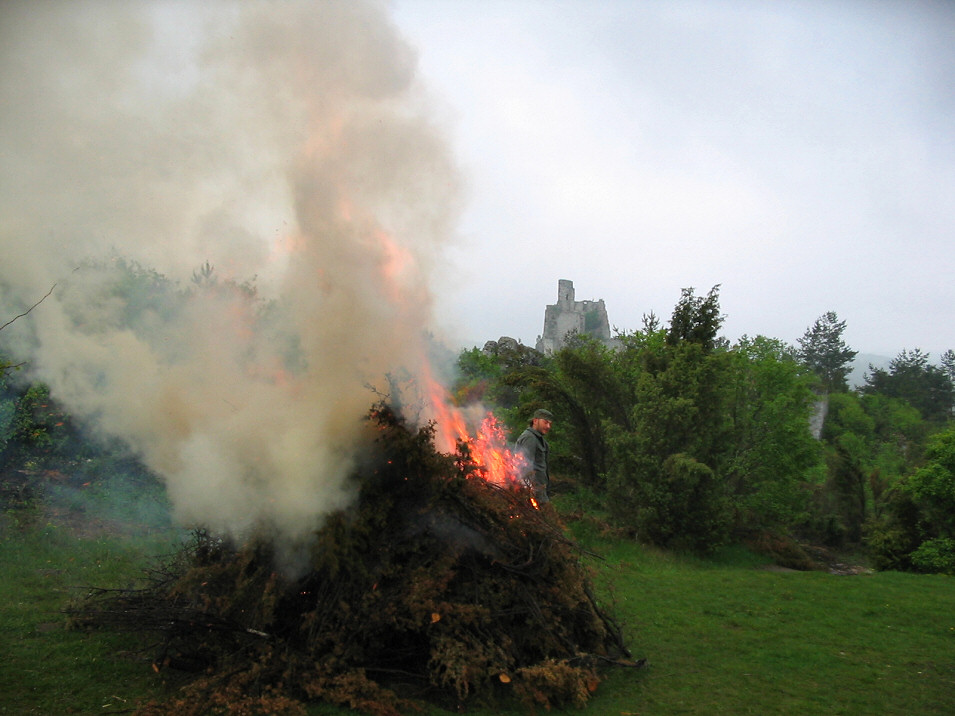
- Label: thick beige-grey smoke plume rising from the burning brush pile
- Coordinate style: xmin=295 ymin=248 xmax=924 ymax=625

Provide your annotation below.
xmin=0 ymin=0 xmax=458 ymax=552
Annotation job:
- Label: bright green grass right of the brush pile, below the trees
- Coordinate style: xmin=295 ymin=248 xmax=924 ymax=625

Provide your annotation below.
xmin=594 ymin=544 xmax=955 ymax=714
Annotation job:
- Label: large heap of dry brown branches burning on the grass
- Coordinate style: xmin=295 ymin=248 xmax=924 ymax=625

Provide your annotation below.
xmin=71 ymin=407 xmax=634 ymax=715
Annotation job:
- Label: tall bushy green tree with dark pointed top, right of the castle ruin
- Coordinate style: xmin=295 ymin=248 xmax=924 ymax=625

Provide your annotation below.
xmin=608 ymin=287 xmax=732 ymax=552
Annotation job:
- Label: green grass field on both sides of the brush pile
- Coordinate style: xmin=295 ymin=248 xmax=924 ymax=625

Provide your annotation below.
xmin=0 ymin=520 xmax=955 ymax=716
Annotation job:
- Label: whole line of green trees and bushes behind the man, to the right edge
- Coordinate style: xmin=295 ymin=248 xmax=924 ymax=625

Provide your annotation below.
xmin=456 ymin=286 xmax=955 ymax=573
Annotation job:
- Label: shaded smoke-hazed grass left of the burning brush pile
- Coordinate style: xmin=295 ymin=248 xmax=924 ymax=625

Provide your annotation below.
xmin=0 ymin=524 xmax=185 ymax=716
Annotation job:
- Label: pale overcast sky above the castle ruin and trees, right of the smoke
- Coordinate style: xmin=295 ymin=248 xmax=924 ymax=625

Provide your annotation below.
xmin=393 ymin=0 xmax=955 ymax=359
